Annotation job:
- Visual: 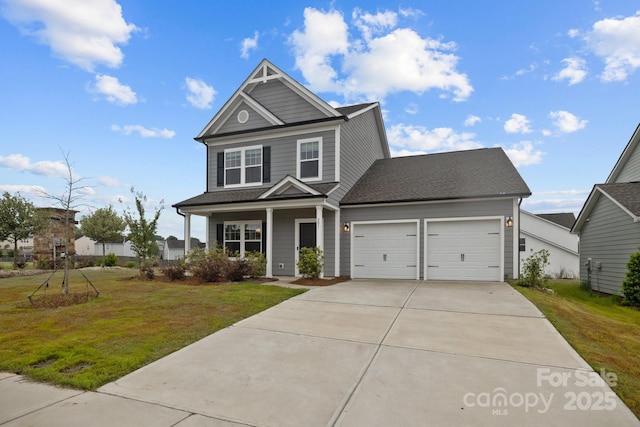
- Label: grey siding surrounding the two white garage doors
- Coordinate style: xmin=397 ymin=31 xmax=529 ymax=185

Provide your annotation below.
xmin=340 ymin=198 xmax=517 ymax=278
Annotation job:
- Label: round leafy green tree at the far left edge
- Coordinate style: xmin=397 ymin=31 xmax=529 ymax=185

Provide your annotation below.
xmin=0 ymin=191 xmax=45 ymax=268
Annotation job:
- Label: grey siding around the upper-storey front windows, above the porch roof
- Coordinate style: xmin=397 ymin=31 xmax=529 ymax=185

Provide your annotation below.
xmin=207 ymin=130 xmax=336 ymax=192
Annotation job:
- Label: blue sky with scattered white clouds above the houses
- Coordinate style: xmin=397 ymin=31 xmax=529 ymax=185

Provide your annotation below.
xmin=0 ymin=0 xmax=640 ymax=239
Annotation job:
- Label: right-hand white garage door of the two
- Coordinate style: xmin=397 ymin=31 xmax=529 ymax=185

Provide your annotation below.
xmin=426 ymin=219 xmax=503 ymax=281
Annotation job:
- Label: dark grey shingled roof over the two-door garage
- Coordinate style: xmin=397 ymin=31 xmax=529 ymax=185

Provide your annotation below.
xmin=340 ymin=148 xmax=531 ymax=205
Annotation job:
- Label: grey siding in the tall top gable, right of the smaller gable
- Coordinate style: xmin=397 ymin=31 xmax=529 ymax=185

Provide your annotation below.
xmin=250 ymin=80 xmax=327 ymax=124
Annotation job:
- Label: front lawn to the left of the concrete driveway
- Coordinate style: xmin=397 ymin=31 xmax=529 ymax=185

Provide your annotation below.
xmin=0 ymin=270 xmax=303 ymax=390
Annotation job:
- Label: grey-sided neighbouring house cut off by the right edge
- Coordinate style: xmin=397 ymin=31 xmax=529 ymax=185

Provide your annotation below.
xmin=571 ymin=125 xmax=640 ymax=295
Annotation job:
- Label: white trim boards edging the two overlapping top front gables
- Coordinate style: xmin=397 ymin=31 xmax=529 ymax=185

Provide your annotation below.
xmin=195 ymin=59 xmax=344 ymax=141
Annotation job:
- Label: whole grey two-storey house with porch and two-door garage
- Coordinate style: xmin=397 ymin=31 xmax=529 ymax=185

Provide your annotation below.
xmin=174 ymin=60 xmax=531 ymax=281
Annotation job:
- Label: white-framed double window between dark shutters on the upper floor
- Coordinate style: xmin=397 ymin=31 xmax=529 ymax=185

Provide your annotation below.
xmin=224 ymin=146 xmax=262 ymax=187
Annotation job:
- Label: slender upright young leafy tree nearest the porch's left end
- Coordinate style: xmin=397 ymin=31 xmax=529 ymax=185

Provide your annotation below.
xmin=124 ymin=187 xmax=164 ymax=276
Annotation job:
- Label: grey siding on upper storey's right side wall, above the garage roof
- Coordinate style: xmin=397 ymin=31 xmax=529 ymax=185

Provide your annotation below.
xmin=330 ymin=110 xmax=384 ymax=204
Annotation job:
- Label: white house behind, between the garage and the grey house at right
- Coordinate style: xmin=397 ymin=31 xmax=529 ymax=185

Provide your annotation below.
xmin=520 ymin=210 xmax=580 ymax=278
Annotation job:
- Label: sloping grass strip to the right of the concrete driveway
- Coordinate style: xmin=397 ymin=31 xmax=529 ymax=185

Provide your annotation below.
xmin=515 ymin=280 xmax=640 ymax=418
